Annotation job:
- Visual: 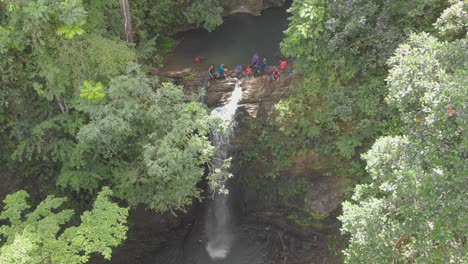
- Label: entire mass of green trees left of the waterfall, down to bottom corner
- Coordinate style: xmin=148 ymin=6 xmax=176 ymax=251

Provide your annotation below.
xmin=0 ymin=0 xmax=227 ymax=258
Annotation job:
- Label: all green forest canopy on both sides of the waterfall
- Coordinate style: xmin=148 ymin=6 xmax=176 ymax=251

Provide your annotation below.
xmin=0 ymin=0 xmax=468 ymax=263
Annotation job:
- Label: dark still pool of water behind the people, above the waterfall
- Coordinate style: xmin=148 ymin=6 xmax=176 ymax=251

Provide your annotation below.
xmin=165 ymin=8 xmax=288 ymax=69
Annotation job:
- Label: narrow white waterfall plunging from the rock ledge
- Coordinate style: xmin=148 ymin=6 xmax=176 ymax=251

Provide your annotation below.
xmin=205 ymin=80 xmax=242 ymax=259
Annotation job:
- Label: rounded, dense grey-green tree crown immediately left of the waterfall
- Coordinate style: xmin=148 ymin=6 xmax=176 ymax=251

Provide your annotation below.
xmin=59 ymin=64 xmax=218 ymax=211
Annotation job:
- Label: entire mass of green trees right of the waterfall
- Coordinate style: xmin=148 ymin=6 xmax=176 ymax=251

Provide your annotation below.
xmin=276 ymin=0 xmax=468 ymax=263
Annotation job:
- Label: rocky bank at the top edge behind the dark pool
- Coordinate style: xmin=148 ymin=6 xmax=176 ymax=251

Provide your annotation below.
xmin=220 ymin=0 xmax=288 ymax=16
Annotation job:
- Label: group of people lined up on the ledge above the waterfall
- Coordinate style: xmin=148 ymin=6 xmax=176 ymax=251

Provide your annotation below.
xmin=208 ymin=53 xmax=288 ymax=81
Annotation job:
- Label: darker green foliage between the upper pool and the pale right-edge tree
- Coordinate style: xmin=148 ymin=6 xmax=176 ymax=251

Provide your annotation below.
xmin=276 ymin=0 xmax=445 ymax=179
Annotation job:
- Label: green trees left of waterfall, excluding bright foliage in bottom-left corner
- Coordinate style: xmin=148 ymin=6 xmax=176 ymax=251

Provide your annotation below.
xmin=0 ymin=0 xmax=219 ymax=214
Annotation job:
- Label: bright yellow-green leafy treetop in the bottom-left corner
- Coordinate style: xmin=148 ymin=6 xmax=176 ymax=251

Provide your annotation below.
xmin=0 ymin=188 xmax=128 ymax=264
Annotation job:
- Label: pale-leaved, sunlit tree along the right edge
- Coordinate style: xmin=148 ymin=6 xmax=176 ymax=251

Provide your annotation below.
xmin=340 ymin=1 xmax=468 ymax=263
